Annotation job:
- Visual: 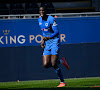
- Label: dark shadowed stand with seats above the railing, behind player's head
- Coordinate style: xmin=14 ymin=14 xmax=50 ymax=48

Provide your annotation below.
xmin=0 ymin=0 xmax=100 ymax=15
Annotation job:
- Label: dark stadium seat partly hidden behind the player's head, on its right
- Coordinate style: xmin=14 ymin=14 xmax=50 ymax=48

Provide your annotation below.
xmin=41 ymin=2 xmax=55 ymax=14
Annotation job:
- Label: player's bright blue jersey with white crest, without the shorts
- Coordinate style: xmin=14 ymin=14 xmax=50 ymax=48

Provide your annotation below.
xmin=38 ymin=16 xmax=59 ymax=38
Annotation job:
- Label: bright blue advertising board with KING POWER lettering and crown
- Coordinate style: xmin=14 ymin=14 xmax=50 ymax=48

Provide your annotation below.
xmin=0 ymin=17 xmax=100 ymax=47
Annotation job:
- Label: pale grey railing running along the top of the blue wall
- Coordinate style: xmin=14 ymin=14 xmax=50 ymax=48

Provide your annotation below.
xmin=0 ymin=12 xmax=100 ymax=19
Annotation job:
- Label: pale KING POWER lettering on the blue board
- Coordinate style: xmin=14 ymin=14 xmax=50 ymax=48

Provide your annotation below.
xmin=0 ymin=34 xmax=66 ymax=44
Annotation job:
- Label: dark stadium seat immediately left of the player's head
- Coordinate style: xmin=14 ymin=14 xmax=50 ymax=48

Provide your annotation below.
xmin=25 ymin=2 xmax=39 ymax=14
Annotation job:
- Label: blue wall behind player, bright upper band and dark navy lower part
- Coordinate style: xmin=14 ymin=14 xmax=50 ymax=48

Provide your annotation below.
xmin=0 ymin=17 xmax=100 ymax=81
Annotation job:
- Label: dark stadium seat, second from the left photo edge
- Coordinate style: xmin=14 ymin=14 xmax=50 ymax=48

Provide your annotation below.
xmin=10 ymin=3 xmax=25 ymax=14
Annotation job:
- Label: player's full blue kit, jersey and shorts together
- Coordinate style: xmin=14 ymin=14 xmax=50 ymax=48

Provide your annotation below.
xmin=38 ymin=16 xmax=60 ymax=55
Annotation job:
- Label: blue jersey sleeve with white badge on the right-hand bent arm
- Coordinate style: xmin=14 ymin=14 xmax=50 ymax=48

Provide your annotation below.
xmin=50 ymin=17 xmax=59 ymax=38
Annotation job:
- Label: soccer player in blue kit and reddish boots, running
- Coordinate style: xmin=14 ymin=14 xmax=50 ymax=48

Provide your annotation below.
xmin=38 ymin=7 xmax=69 ymax=87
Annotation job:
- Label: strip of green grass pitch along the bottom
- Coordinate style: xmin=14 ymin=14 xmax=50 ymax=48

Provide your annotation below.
xmin=0 ymin=77 xmax=100 ymax=89
